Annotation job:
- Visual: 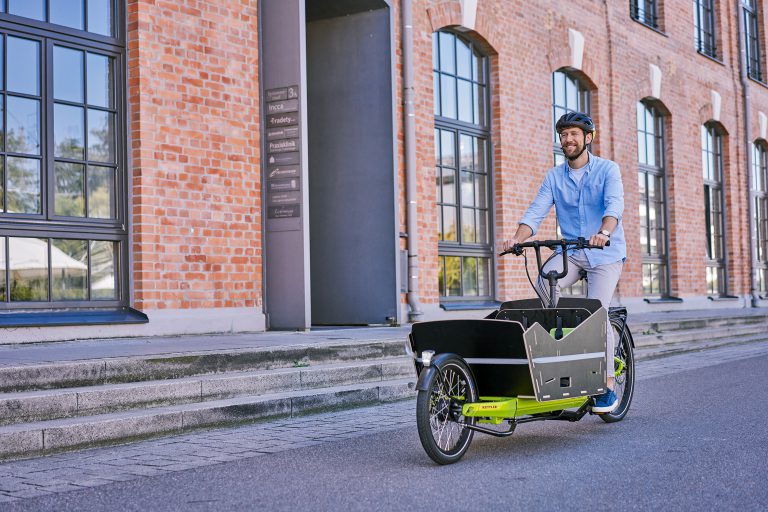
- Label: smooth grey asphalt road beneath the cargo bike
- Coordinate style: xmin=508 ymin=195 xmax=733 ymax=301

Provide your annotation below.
xmin=0 ymin=344 xmax=768 ymax=512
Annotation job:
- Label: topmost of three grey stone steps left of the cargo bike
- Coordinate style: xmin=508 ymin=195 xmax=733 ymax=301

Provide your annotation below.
xmin=0 ymin=338 xmax=412 ymax=393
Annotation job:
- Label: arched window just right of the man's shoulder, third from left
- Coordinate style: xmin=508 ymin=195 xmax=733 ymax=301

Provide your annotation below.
xmin=637 ymin=101 xmax=669 ymax=297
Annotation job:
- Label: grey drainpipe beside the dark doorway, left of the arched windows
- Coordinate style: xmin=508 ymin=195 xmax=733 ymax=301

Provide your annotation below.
xmin=400 ymin=0 xmax=423 ymax=322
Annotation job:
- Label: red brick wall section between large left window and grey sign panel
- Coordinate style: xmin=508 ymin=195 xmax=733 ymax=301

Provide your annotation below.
xmin=127 ymin=0 xmax=262 ymax=310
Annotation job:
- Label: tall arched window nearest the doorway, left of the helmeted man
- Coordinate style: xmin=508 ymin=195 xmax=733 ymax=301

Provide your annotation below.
xmin=432 ymin=32 xmax=493 ymax=302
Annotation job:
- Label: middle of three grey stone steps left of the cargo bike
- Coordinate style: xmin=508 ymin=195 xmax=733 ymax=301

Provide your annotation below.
xmin=0 ymin=357 xmax=415 ymax=425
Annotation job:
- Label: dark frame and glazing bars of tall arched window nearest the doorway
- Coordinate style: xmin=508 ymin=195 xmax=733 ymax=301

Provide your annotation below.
xmin=432 ymin=30 xmax=495 ymax=304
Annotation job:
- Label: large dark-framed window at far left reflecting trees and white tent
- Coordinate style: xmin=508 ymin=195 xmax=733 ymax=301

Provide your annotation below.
xmin=0 ymin=0 xmax=128 ymax=310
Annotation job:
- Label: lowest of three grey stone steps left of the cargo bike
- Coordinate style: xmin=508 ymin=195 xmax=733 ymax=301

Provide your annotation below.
xmin=0 ymin=378 xmax=415 ymax=459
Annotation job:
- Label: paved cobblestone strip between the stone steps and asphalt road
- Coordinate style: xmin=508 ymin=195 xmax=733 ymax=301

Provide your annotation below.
xmin=0 ymin=341 xmax=768 ymax=508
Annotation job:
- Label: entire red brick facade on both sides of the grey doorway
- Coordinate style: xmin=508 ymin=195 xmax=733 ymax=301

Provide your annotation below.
xmin=128 ymin=0 xmax=768 ymax=322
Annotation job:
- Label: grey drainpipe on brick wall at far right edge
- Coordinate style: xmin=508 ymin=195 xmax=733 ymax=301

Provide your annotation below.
xmin=736 ymin=2 xmax=759 ymax=308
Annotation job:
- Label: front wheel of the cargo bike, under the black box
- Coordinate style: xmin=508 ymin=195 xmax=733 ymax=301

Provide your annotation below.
xmin=416 ymin=356 xmax=477 ymax=464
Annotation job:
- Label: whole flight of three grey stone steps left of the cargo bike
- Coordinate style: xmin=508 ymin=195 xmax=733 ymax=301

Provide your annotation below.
xmin=0 ymin=337 xmax=416 ymax=459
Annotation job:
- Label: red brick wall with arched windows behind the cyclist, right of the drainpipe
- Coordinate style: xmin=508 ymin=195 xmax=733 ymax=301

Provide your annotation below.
xmin=414 ymin=0 xmax=768 ymax=303
